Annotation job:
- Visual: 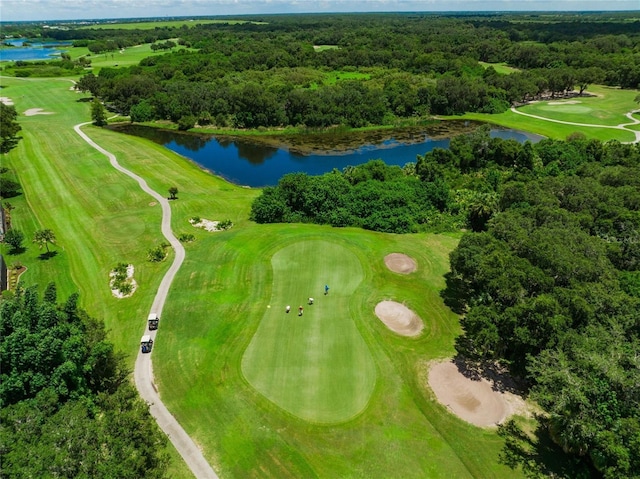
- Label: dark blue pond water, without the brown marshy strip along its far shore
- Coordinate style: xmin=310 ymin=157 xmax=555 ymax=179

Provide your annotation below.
xmin=116 ymin=122 xmax=542 ymax=187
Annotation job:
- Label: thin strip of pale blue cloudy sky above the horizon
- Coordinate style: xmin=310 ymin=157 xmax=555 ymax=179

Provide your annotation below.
xmin=0 ymin=0 xmax=640 ymax=21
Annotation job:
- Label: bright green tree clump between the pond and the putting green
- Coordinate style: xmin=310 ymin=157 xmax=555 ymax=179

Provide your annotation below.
xmin=251 ymin=160 xmax=450 ymax=233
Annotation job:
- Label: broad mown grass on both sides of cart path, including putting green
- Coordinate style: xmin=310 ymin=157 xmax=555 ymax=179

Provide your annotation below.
xmin=1 ymin=78 xmax=521 ymax=479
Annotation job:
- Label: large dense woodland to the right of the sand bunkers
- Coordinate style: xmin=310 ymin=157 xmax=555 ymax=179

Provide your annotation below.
xmin=449 ymin=139 xmax=640 ymax=478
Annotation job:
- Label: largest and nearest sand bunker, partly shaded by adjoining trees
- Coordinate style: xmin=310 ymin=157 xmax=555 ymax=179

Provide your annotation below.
xmin=428 ymin=361 xmax=526 ymax=427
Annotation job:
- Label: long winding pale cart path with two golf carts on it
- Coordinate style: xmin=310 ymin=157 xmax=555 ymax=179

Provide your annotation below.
xmin=73 ymin=122 xmax=219 ymax=479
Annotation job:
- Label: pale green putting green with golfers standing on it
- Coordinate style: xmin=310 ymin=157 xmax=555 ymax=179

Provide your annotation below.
xmin=242 ymin=240 xmax=376 ymax=423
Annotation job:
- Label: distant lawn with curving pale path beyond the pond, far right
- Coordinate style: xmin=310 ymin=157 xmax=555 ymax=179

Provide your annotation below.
xmin=450 ymin=85 xmax=638 ymax=142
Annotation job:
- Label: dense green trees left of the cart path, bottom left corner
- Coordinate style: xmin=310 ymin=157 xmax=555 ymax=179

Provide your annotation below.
xmin=0 ymin=283 xmax=167 ymax=478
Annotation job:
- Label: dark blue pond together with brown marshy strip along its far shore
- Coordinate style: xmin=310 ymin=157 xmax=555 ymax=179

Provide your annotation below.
xmin=114 ymin=122 xmax=542 ymax=187
